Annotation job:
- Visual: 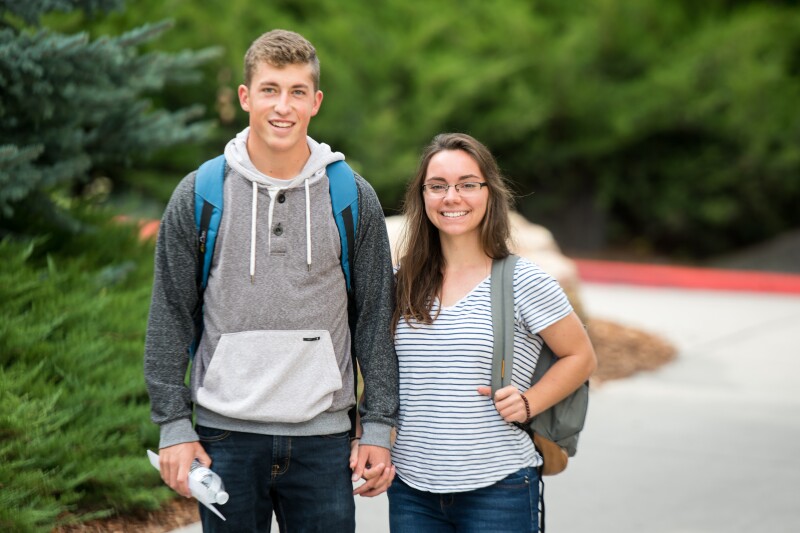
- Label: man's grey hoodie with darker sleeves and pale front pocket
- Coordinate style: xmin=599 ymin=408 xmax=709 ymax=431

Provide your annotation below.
xmin=145 ymin=130 xmax=398 ymax=448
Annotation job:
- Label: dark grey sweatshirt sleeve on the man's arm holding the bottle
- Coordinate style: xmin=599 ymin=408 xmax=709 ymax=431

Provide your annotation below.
xmin=144 ymin=174 xmax=205 ymax=448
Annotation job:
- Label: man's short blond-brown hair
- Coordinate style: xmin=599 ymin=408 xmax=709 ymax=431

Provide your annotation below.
xmin=244 ymin=30 xmax=319 ymax=91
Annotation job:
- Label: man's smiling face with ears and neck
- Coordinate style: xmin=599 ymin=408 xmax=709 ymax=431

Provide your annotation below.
xmin=239 ymin=62 xmax=322 ymax=157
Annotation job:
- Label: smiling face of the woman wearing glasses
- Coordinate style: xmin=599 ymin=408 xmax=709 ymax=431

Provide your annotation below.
xmin=422 ymin=150 xmax=489 ymax=237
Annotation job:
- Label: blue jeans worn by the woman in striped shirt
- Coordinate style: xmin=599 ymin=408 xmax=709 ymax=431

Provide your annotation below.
xmin=389 ymin=467 xmax=539 ymax=533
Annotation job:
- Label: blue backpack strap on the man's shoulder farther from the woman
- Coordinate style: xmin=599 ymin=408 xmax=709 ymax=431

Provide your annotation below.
xmin=194 ymin=155 xmax=225 ymax=292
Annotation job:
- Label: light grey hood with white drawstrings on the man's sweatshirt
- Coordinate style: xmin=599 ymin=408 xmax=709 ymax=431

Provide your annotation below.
xmin=225 ymin=127 xmax=344 ymax=281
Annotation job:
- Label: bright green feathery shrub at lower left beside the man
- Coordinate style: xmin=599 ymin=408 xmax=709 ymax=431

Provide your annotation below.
xmin=0 ymin=213 xmax=170 ymax=531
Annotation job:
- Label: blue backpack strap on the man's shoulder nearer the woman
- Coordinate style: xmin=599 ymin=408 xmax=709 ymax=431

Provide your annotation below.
xmin=327 ymin=161 xmax=358 ymax=293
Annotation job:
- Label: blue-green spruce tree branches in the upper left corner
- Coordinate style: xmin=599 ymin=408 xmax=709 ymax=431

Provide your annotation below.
xmin=0 ymin=0 xmax=218 ymax=233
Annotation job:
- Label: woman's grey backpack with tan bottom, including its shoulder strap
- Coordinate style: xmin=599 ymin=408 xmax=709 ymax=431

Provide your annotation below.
xmin=491 ymin=255 xmax=589 ymax=475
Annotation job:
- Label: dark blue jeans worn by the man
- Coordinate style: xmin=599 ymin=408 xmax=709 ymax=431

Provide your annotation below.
xmin=197 ymin=426 xmax=355 ymax=533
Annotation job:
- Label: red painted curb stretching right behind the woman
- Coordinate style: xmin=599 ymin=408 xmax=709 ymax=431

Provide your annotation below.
xmin=574 ymin=259 xmax=800 ymax=294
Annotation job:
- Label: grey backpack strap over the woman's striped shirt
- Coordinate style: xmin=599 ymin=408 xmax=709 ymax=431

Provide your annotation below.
xmin=490 ymin=255 xmax=519 ymax=394
